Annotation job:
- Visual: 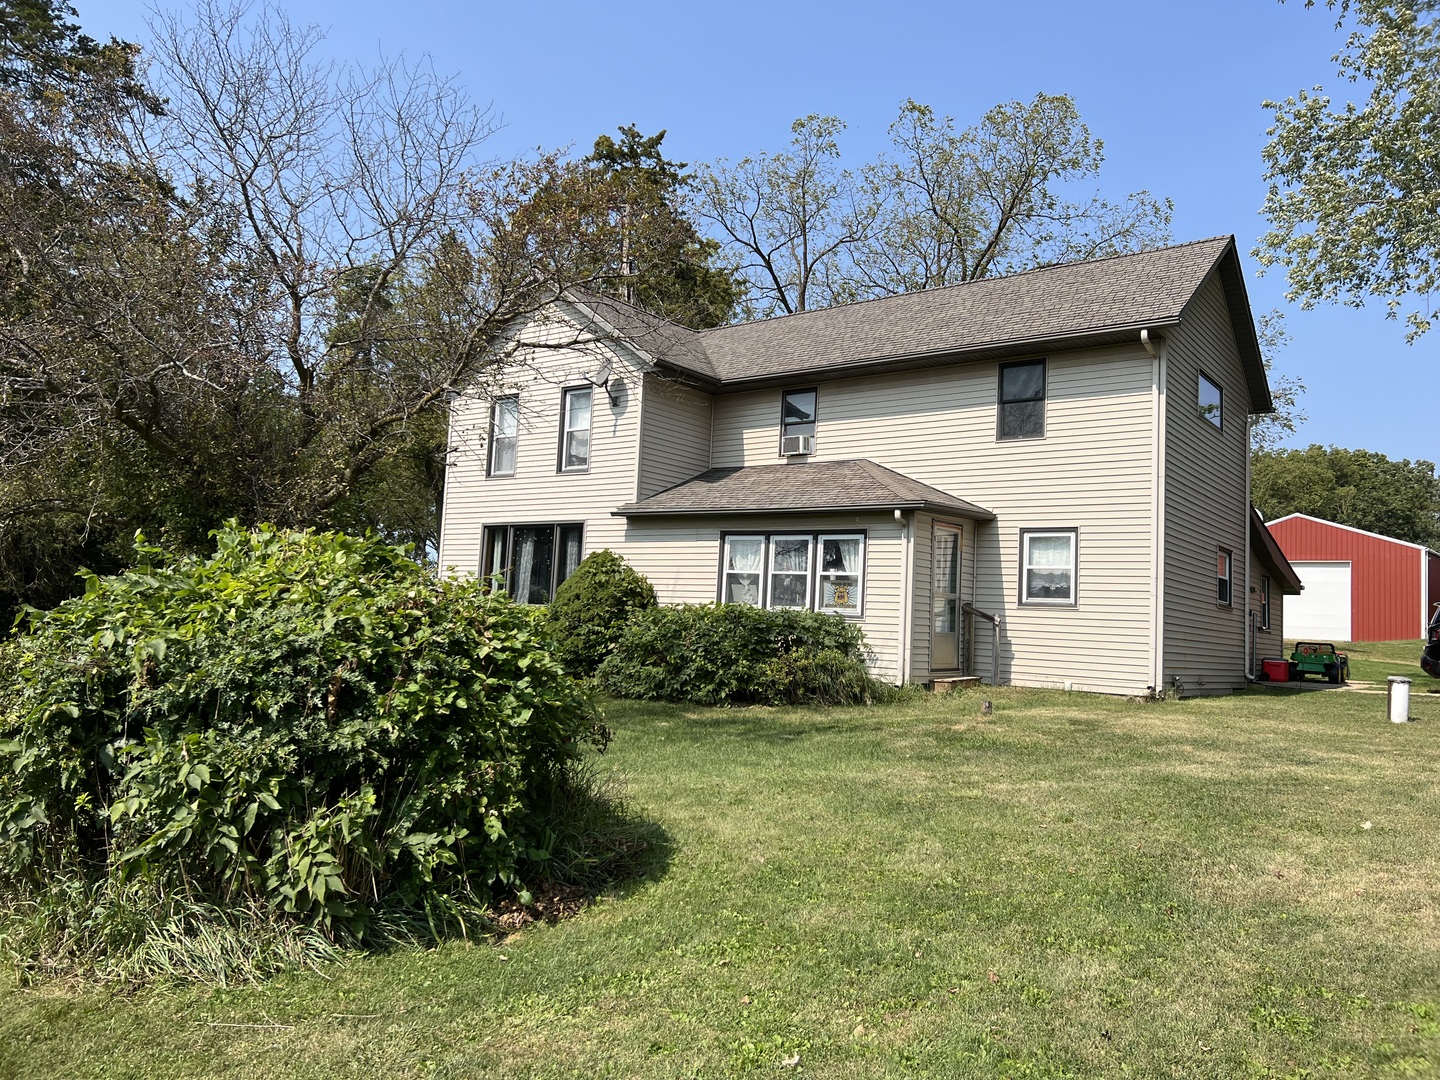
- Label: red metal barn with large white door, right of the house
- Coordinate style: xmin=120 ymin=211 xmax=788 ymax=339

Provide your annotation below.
xmin=1266 ymin=514 xmax=1440 ymax=641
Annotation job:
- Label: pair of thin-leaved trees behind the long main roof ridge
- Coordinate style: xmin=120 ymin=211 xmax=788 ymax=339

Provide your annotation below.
xmin=700 ymin=94 xmax=1171 ymax=315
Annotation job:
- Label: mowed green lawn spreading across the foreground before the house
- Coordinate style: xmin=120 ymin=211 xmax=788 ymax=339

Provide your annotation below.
xmin=0 ymin=690 xmax=1440 ymax=1080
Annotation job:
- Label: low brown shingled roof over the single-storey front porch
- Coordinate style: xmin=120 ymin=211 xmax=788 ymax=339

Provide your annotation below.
xmin=613 ymin=458 xmax=995 ymax=521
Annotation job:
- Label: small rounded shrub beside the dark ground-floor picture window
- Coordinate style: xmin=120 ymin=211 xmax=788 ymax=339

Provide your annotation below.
xmin=550 ymin=549 xmax=655 ymax=675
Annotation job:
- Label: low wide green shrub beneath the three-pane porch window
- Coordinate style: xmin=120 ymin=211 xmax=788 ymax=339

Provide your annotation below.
xmin=598 ymin=603 xmax=893 ymax=706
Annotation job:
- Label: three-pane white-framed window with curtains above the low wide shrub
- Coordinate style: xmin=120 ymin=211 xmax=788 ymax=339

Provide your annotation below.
xmin=720 ymin=533 xmax=865 ymax=615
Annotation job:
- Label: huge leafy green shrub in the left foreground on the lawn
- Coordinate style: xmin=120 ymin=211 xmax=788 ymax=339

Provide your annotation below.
xmin=0 ymin=528 xmax=603 ymax=979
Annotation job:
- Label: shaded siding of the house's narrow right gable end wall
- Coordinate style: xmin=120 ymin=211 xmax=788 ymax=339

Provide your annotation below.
xmin=1164 ymin=274 xmax=1250 ymax=694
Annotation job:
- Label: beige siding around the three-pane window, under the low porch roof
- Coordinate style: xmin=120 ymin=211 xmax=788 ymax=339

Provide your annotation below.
xmin=624 ymin=514 xmax=904 ymax=683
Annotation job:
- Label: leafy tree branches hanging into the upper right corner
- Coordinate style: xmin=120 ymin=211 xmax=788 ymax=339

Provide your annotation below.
xmin=1256 ymin=0 xmax=1440 ymax=341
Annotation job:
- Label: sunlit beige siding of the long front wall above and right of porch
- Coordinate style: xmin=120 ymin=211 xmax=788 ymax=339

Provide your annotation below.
xmin=711 ymin=348 xmax=1153 ymax=694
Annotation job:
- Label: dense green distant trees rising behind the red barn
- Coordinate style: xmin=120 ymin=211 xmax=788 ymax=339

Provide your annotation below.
xmin=1251 ymin=445 xmax=1440 ymax=547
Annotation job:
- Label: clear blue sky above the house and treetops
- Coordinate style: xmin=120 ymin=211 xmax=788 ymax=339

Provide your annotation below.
xmin=73 ymin=0 xmax=1440 ymax=461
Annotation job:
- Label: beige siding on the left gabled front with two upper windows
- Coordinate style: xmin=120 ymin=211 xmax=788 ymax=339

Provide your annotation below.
xmin=439 ymin=320 xmax=641 ymax=584
